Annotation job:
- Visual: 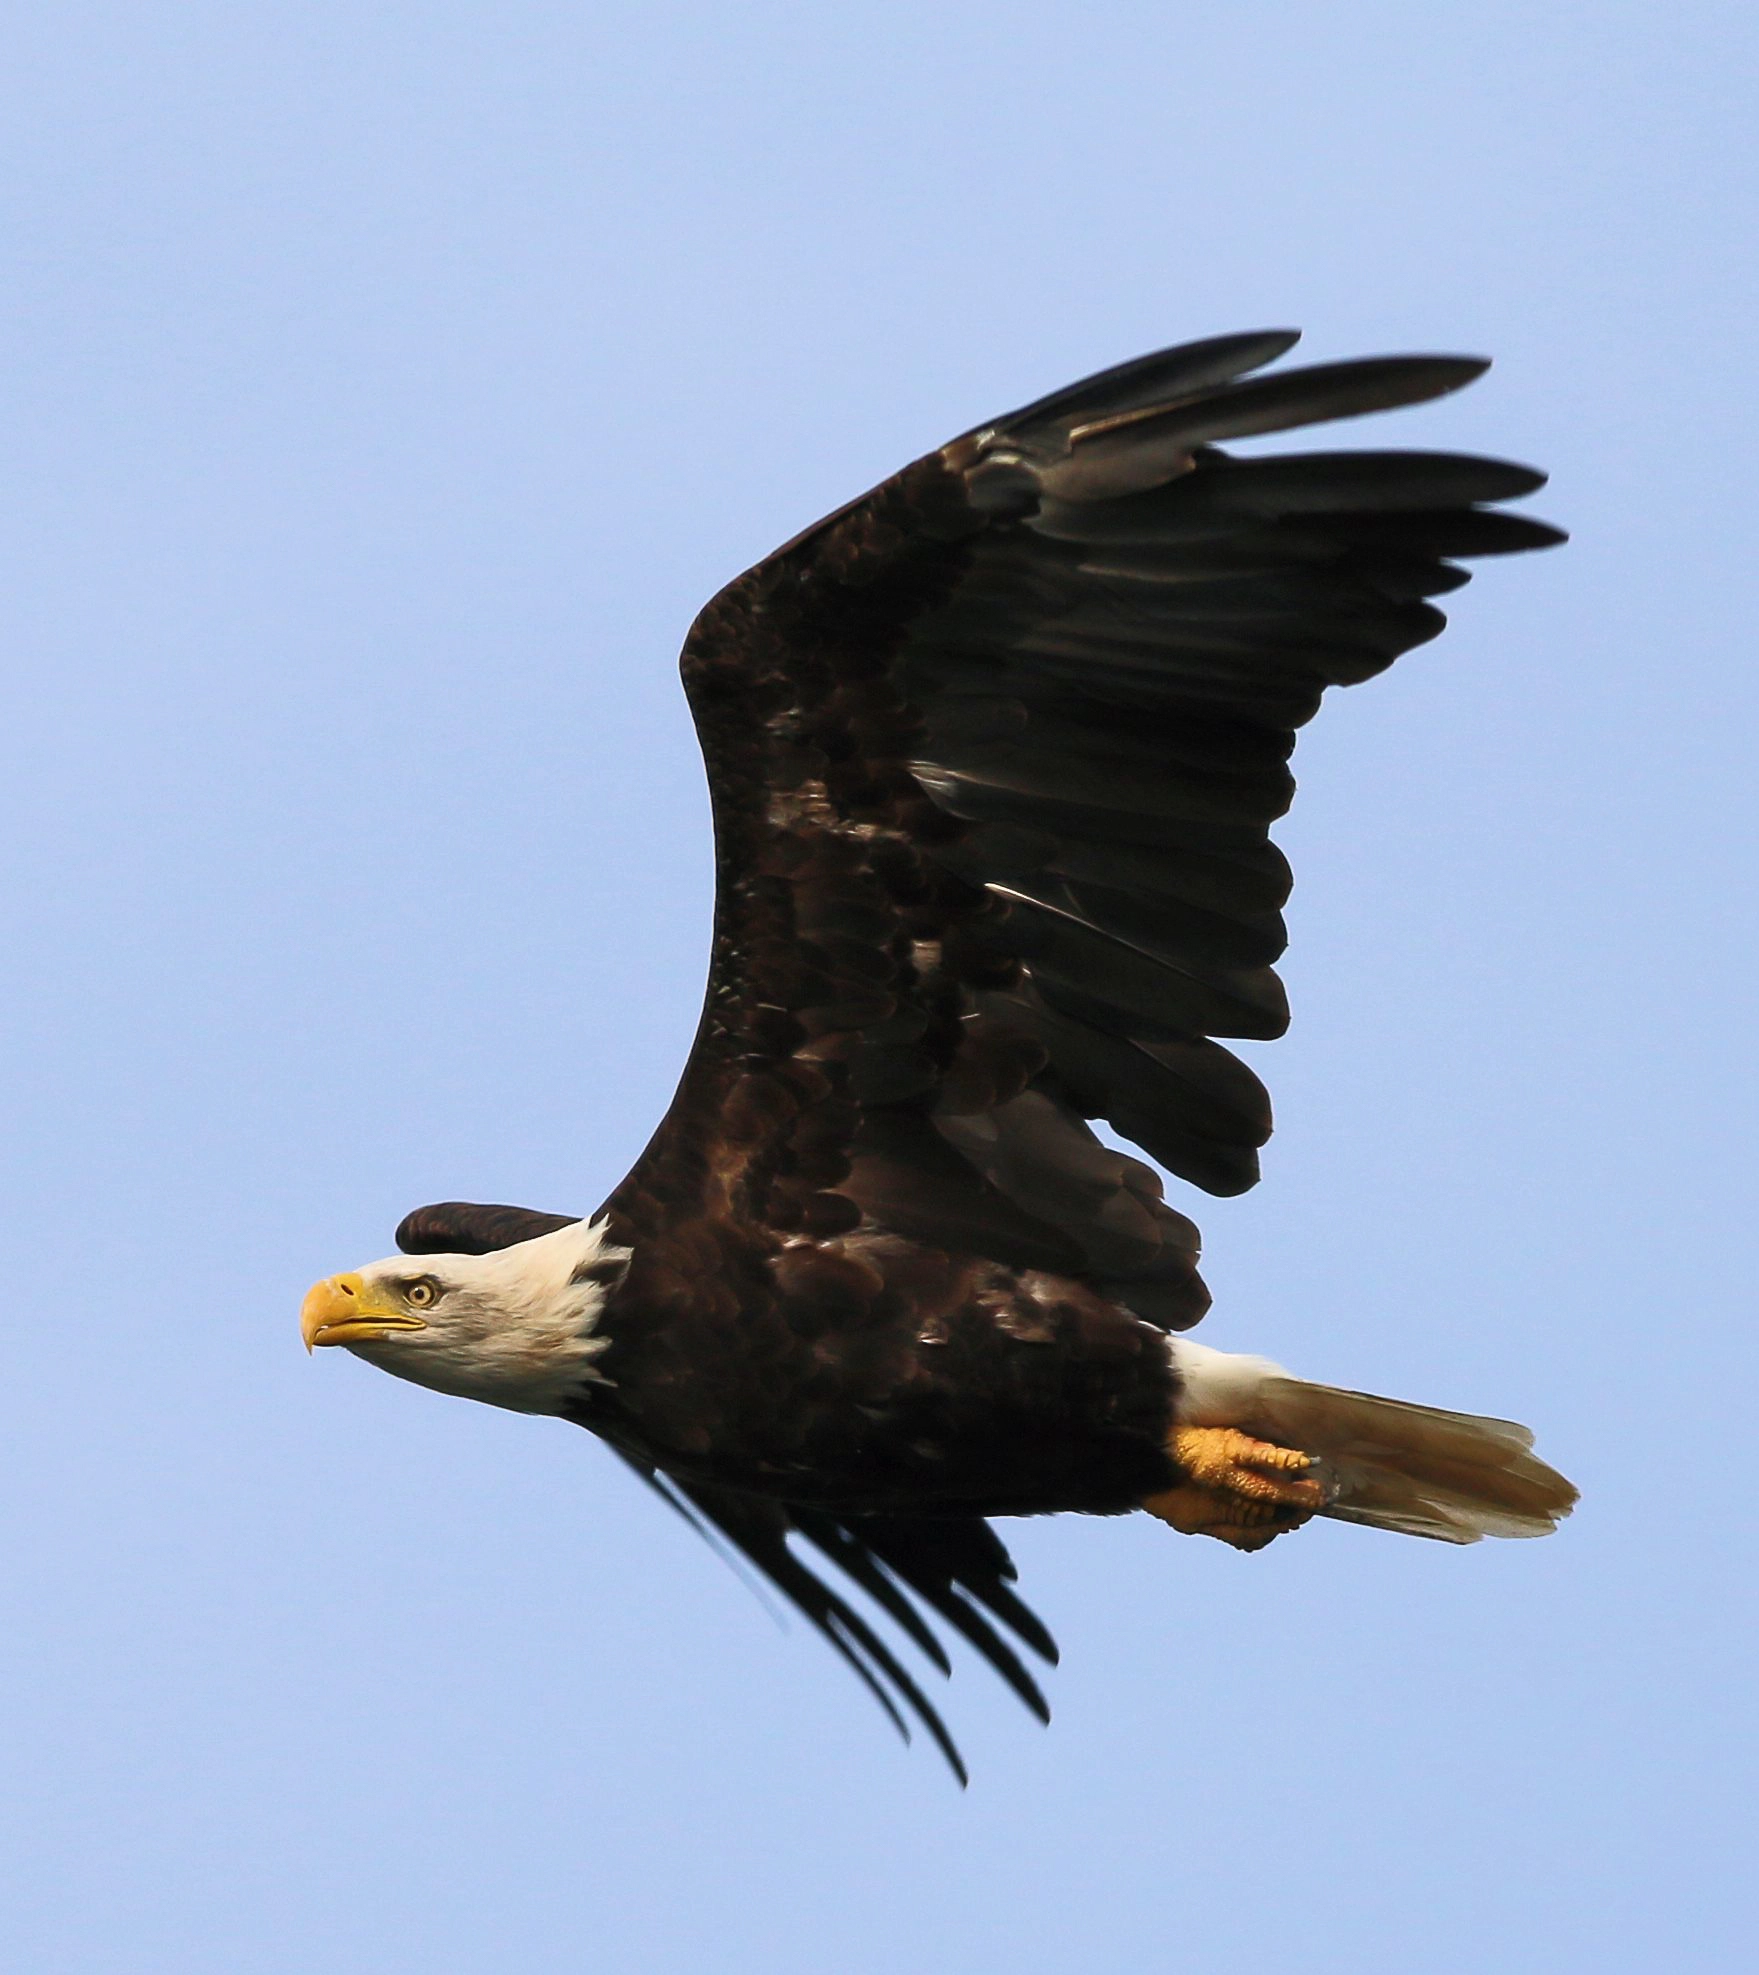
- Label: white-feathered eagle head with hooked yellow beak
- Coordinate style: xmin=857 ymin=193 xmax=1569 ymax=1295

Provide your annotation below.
xmin=300 ymin=1221 xmax=630 ymax=1412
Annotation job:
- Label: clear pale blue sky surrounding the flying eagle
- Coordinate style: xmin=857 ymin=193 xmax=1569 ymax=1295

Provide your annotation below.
xmin=0 ymin=0 xmax=1759 ymax=1975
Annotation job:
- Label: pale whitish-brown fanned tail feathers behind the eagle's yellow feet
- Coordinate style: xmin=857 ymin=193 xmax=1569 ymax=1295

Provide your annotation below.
xmin=1234 ymin=1371 xmax=1575 ymax=1542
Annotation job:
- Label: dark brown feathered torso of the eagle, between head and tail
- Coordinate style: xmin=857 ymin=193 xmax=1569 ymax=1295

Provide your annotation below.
xmin=592 ymin=1234 xmax=1177 ymax=1515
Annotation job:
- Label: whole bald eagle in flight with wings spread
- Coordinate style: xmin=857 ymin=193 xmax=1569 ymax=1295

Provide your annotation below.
xmin=302 ymin=332 xmax=1575 ymax=1779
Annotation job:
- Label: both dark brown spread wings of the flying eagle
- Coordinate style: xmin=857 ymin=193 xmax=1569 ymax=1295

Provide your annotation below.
xmin=411 ymin=332 xmax=1562 ymax=1762
